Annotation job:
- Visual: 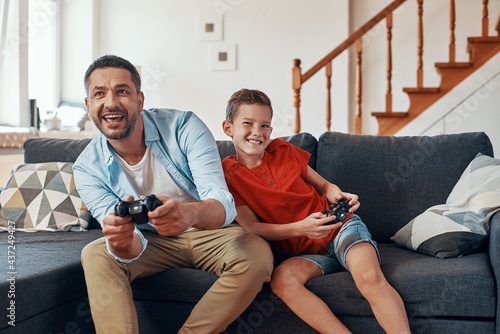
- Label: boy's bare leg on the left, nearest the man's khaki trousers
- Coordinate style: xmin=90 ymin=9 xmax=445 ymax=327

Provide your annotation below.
xmin=271 ymin=258 xmax=350 ymax=333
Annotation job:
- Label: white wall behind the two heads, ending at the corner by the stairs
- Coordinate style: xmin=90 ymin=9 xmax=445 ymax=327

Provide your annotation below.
xmin=61 ymin=0 xmax=348 ymax=139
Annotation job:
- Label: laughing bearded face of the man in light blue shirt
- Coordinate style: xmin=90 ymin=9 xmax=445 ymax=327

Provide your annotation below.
xmin=85 ymin=67 xmax=144 ymax=140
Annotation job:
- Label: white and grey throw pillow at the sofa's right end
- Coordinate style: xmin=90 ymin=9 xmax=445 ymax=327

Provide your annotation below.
xmin=393 ymin=153 xmax=500 ymax=258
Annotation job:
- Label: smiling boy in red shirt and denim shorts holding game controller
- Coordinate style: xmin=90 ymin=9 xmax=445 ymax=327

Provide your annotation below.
xmin=222 ymin=89 xmax=410 ymax=333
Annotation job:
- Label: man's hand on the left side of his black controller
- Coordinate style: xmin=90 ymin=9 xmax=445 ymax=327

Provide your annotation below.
xmin=102 ymin=196 xmax=142 ymax=259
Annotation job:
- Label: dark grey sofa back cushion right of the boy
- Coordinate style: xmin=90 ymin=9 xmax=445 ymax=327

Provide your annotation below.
xmin=316 ymin=132 xmax=493 ymax=242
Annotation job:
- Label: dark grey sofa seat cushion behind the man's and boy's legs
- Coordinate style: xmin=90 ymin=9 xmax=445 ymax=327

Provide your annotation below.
xmin=132 ymin=244 xmax=496 ymax=318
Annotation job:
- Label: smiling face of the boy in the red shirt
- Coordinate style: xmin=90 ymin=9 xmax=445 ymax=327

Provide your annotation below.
xmin=222 ymin=104 xmax=272 ymax=163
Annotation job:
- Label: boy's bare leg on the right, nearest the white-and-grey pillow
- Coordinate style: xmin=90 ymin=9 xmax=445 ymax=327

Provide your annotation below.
xmin=346 ymin=242 xmax=410 ymax=334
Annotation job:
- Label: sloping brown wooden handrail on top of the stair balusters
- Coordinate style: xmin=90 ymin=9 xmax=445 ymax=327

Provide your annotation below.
xmin=301 ymin=0 xmax=406 ymax=83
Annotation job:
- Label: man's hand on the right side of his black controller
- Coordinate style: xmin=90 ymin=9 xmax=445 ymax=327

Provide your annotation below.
xmin=148 ymin=196 xmax=192 ymax=236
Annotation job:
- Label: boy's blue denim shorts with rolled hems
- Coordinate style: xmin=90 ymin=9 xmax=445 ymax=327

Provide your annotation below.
xmin=295 ymin=215 xmax=380 ymax=275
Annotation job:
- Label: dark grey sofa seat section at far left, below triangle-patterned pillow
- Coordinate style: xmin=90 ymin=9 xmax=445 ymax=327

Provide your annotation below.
xmin=0 ymin=229 xmax=103 ymax=330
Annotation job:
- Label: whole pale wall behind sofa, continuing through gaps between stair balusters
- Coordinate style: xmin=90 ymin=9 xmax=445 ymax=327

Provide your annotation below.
xmin=54 ymin=0 xmax=500 ymax=139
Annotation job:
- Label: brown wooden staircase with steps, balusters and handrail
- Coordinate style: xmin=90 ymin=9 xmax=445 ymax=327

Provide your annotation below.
xmin=293 ymin=0 xmax=500 ymax=135
